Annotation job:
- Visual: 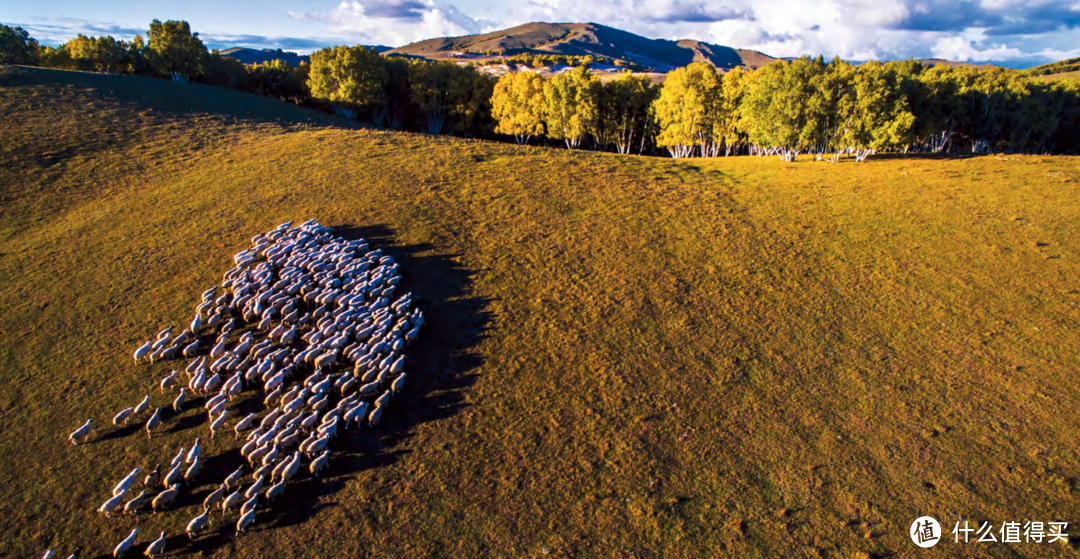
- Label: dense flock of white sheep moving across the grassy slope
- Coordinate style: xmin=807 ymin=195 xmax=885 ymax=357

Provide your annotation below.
xmin=52 ymin=221 xmax=423 ymax=558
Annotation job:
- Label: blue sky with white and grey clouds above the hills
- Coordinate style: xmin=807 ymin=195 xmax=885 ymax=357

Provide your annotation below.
xmin=0 ymin=0 xmax=1080 ymax=67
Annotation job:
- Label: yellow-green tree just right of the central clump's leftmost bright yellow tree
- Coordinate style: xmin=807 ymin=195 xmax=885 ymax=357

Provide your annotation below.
xmin=543 ymin=66 xmax=599 ymax=149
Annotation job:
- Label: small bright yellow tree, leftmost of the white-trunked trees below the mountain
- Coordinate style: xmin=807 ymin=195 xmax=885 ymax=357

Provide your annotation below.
xmin=491 ymin=71 xmax=546 ymax=145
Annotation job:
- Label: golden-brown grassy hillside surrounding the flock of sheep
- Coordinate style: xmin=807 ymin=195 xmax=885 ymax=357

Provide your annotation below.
xmin=6 ymin=67 xmax=1080 ymax=558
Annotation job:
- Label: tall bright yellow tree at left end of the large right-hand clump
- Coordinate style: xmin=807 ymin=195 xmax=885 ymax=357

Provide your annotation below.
xmin=652 ymin=63 xmax=723 ymax=158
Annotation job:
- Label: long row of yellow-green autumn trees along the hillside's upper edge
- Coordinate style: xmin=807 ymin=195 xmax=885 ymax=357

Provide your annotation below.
xmin=6 ymin=19 xmax=1080 ymax=161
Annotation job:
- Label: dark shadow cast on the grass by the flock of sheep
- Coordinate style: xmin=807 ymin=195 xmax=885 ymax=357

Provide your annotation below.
xmin=86 ymin=226 xmax=489 ymax=557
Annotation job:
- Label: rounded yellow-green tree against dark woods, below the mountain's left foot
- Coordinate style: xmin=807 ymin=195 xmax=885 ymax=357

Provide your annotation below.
xmin=308 ymin=46 xmax=388 ymax=118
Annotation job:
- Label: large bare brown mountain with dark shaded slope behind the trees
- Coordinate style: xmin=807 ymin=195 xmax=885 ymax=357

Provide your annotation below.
xmin=387 ymin=23 xmax=775 ymax=72
